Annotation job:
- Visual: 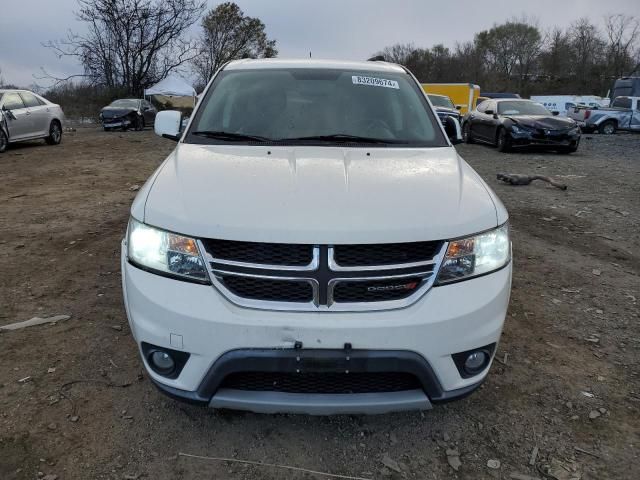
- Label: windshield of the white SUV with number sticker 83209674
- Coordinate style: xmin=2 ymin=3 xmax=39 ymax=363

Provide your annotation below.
xmin=186 ymin=68 xmax=447 ymax=146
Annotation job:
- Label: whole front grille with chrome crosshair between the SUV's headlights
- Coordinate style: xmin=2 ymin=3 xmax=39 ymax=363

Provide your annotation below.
xmin=201 ymin=240 xmax=445 ymax=311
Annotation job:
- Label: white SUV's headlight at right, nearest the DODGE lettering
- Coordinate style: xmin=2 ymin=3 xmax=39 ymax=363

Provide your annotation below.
xmin=436 ymin=223 xmax=511 ymax=284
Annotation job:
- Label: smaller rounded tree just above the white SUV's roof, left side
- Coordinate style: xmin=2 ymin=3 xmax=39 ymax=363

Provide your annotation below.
xmin=191 ymin=2 xmax=278 ymax=86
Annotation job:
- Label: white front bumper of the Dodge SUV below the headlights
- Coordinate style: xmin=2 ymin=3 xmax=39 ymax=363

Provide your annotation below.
xmin=122 ymin=244 xmax=511 ymax=414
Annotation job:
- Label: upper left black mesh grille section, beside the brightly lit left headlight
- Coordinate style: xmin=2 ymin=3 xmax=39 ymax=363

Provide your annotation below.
xmin=204 ymin=240 xmax=313 ymax=266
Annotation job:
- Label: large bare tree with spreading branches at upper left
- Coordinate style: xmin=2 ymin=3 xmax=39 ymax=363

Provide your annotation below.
xmin=41 ymin=0 xmax=205 ymax=95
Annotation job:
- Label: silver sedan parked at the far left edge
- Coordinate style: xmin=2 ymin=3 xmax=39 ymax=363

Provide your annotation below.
xmin=0 ymin=90 xmax=64 ymax=153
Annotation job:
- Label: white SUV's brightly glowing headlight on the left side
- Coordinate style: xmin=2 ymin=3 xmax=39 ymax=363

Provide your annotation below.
xmin=127 ymin=218 xmax=209 ymax=282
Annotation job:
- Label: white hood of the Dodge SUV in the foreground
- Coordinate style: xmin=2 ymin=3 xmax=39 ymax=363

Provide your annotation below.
xmin=139 ymin=143 xmax=507 ymax=244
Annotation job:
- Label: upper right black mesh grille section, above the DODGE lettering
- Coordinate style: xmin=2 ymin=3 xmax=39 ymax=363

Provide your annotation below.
xmin=334 ymin=242 xmax=442 ymax=267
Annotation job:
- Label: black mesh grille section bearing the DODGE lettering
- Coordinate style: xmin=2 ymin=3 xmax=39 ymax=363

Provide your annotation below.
xmin=333 ymin=277 xmax=422 ymax=303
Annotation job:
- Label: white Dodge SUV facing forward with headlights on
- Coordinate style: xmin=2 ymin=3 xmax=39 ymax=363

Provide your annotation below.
xmin=122 ymin=59 xmax=511 ymax=414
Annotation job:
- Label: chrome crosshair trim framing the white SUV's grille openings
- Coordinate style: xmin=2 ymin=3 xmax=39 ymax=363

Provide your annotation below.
xmin=197 ymin=240 xmax=449 ymax=312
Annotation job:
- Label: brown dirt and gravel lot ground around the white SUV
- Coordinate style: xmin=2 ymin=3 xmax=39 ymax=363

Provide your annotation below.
xmin=0 ymin=129 xmax=640 ymax=480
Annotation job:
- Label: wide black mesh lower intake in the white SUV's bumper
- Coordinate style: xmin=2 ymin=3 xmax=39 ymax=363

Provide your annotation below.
xmin=222 ymin=372 xmax=422 ymax=394
